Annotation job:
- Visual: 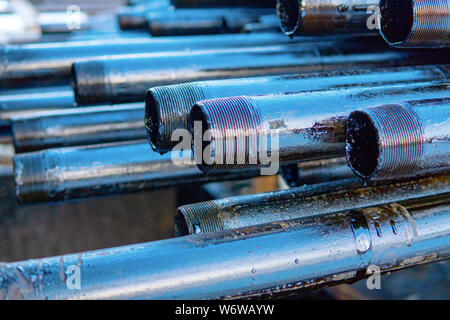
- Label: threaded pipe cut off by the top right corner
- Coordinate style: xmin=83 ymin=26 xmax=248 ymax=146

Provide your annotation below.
xmin=380 ymin=0 xmax=450 ymax=48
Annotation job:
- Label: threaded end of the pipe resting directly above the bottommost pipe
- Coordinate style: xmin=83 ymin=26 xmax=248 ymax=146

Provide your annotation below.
xmin=175 ymin=200 xmax=223 ymax=236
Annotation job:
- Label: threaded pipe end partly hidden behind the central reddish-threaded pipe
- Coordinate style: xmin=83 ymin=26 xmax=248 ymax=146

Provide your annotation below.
xmin=145 ymin=83 xmax=205 ymax=154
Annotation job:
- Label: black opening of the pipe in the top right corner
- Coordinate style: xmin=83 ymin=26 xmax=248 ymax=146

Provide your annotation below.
xmin=380 ymin=0 xmax=414 ymax=44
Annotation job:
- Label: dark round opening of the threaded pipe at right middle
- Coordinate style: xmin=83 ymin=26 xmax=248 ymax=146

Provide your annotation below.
xmin=346 ymin=111 xmax=380 ymax=179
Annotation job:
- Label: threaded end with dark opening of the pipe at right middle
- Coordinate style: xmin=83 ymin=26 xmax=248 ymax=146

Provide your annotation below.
xmin=346 ymin=102 xmax=425 ymax=180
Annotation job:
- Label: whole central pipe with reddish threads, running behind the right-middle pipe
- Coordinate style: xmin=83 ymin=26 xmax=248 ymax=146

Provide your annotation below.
xmin=190 ymin=82 xmax=450 ymax=172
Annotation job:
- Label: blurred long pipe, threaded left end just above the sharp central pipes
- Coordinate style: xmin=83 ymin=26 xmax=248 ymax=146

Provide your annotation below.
xmin=72 ymin=36 xmax=448 ymax=104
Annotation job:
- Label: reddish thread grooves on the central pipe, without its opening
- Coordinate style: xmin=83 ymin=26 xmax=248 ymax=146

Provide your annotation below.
xmin=199 ymin=96 xmax=262 ymax=171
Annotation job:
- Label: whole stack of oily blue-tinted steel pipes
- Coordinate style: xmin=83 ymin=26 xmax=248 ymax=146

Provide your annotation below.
xmin=0 ymin=0 xmax=450 ymax=299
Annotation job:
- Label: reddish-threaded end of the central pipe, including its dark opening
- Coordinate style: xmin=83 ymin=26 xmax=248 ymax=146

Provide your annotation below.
xmin=189 ymin=96 xmax=262 ymax=172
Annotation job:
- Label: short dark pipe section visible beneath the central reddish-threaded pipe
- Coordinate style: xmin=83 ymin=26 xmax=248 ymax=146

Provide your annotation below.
xmin=280 ymin=157 xmax=354 ymax=187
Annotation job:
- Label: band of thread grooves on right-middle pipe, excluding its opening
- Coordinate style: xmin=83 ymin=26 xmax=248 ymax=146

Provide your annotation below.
xmin=367 ymin=103 xmax=425 ymax=179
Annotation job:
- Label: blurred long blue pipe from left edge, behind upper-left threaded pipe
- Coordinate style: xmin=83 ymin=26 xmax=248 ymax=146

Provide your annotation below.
xmin=0 ymin=34 xmax=296 ymax=89
